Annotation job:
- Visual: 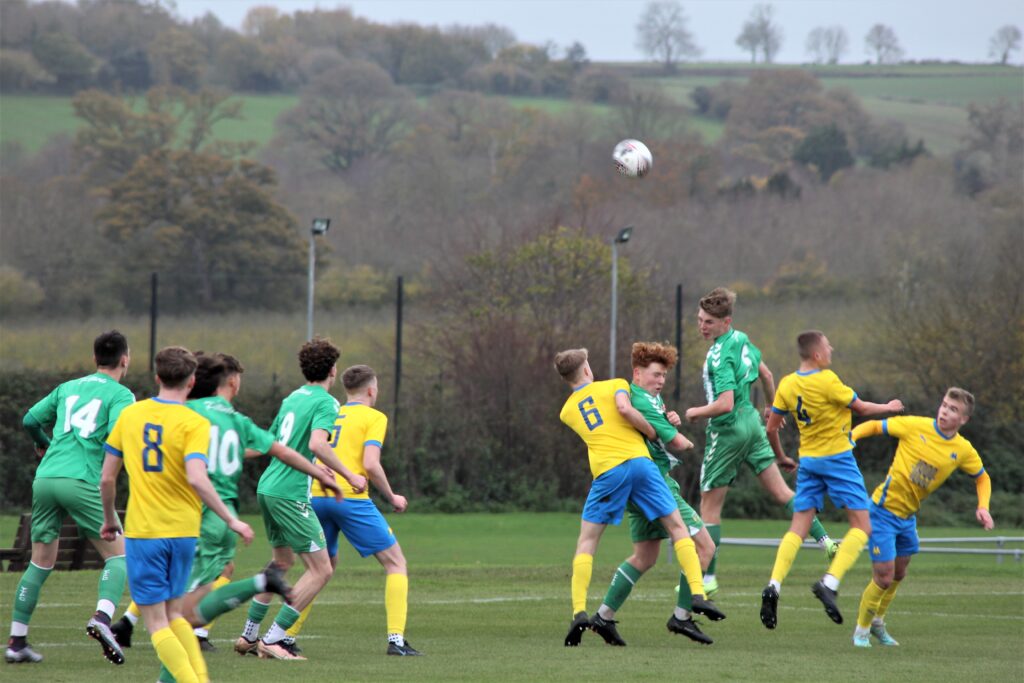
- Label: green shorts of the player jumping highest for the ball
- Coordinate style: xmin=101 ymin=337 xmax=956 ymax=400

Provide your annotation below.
xmin=700 ymin=405 xmax=775 ymax=492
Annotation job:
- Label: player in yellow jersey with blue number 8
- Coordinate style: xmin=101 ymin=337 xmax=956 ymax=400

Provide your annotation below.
xmin=99 ymin=346 xmax=253 ymax=683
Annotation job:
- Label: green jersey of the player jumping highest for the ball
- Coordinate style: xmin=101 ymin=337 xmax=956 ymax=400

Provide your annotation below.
xmin=703 ymin=328 xmax=761 ymax=427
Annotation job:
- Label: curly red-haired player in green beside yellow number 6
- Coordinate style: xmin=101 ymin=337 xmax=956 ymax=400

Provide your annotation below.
xmin=591 ymin=342 xmax=715 ymax=645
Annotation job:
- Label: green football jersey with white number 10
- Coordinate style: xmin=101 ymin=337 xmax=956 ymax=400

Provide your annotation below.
xmin=186 ymin=396 xmax=273 ymax=501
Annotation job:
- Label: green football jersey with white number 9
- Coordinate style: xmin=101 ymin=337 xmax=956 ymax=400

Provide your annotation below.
xmin=256 ymin=384 xmax=339 ymax=501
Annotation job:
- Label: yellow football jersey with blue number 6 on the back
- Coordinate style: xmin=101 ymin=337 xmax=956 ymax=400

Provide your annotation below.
xmin=558 ymin=379 xmax=650 ymax=479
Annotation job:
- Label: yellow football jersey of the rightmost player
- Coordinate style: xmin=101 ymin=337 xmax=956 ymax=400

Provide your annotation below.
xmin=853 ymin=416 xmax=985 ymax=519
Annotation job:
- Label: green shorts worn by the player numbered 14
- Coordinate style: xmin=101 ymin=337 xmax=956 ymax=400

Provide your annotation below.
xmin=32 ymin=478 xmax=103 ymax=543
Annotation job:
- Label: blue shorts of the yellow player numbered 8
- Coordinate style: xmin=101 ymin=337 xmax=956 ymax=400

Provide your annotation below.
xmin=125 ymin=537 xmax=196 ymax=605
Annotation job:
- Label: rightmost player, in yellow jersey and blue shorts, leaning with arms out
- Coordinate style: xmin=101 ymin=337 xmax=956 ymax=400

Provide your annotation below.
xmin=853 ymin=387 xmax=995 ymax=647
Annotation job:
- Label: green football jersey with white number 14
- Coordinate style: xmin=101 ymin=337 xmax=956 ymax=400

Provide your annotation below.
xmin=29 ymin=373 xmax=135 ymax=485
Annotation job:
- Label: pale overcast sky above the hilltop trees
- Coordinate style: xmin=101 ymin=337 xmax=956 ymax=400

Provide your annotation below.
xmin=177 ymin=0 xmax=1024 ymax=63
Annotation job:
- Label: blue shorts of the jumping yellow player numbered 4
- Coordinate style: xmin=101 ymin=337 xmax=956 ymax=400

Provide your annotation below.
xmin=793 ymin=451 xmax=871 ymax=512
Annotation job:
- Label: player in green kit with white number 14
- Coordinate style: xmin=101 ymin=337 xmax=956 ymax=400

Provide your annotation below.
xmin=5 ymin=330 xmax=135 ymax=664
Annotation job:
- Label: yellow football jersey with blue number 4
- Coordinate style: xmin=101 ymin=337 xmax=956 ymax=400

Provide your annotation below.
xmin=771 ymin=370 xmax=857 ymax=458
